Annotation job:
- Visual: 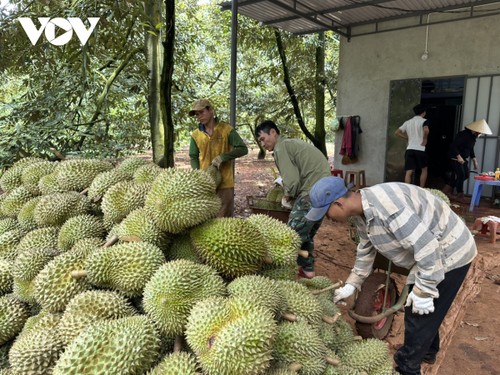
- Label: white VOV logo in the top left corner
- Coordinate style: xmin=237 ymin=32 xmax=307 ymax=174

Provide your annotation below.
xmin=19 ymin=17 xmax=99 ymax=46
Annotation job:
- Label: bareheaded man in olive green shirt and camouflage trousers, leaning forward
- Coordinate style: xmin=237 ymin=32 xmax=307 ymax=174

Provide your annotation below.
xmin=255 ymin=120 xmax=331 ymax=279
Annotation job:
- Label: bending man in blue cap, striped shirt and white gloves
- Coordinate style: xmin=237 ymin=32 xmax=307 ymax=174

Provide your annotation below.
xmin=306 ymin=176 xmax=477 ymax=375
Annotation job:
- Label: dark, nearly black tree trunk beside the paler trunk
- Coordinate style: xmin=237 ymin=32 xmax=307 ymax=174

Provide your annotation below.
xmin=161 ymin=0 xmax=175 ymax=167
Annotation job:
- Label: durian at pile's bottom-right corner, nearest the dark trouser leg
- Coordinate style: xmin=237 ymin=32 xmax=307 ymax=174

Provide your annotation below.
xmin=338 ymin=339 xmax=392 ymax=373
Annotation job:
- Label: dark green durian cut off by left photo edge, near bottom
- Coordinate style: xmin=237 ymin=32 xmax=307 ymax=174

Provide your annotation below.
xmin=0 ymin=294 xmax=29 ymax=345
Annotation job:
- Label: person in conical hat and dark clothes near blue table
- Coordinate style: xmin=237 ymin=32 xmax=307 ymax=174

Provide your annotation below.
xmin=443 ymin=120 xmax=492 ymax=203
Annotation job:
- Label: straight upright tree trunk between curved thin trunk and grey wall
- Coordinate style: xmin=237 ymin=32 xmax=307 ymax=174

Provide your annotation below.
xmin=314 ymin=32 xmax=328 ymax=157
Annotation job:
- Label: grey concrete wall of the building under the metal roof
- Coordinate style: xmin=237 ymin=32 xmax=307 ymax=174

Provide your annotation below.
xmin=334 ymin=15 xmax=500 ymax=185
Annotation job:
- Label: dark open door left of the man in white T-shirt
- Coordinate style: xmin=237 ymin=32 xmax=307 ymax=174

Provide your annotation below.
xmin=384 ymin=79 xmax=422 ymax=182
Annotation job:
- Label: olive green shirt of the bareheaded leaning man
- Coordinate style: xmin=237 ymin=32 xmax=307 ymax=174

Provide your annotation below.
xmin=273 ymin=135 xmax=331 ymax=198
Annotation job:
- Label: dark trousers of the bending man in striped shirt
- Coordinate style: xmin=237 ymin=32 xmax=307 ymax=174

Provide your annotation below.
xmin=394 ymin=263 xmax=470 ymax=375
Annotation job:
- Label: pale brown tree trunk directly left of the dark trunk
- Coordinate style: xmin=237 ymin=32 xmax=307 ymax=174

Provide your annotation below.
xmin=145 ymin=0 xmax=165 ymax=164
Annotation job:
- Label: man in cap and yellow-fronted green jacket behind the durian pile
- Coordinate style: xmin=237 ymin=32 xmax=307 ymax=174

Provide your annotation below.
xmin=189 ymin=99 xmax=248 ymax=217
